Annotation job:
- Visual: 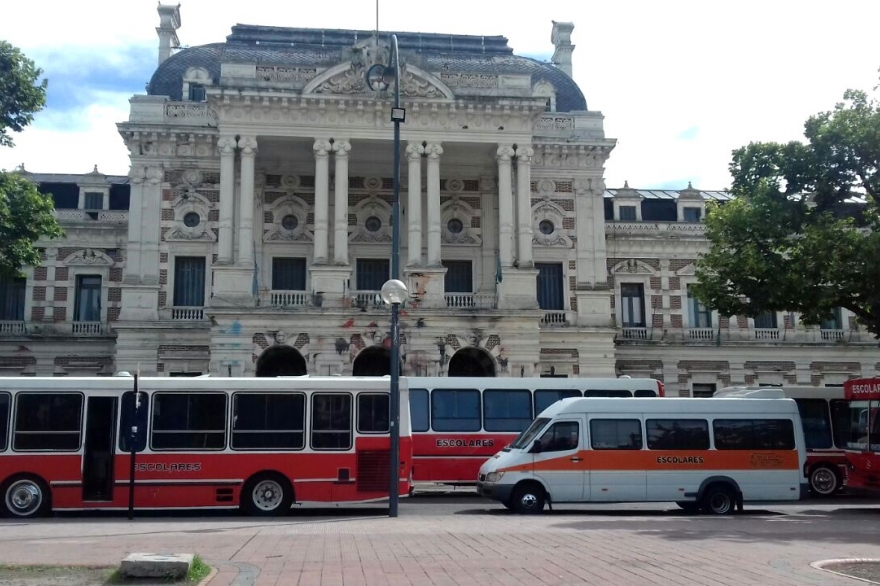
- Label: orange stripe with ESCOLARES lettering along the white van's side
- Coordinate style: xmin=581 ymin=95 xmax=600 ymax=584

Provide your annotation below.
xmin=498 ymin=450 xmax=800 ymax=472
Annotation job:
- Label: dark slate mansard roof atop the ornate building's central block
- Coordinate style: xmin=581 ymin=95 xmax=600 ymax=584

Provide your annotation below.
xmin=147 ymin=24 xmax=587 ymax=112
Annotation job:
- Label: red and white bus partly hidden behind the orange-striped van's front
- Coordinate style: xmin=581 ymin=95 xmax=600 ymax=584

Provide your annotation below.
xmin=407 ymin=377 xmax=664 ymax=484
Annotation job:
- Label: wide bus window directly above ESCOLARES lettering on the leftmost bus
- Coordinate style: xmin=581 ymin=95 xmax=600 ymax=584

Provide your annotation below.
xmin=151 ymin=393 xmax=226 ymax=450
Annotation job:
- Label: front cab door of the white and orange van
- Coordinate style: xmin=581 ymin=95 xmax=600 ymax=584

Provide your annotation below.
xmin=532 ymin=416 xmax=590 ymax=503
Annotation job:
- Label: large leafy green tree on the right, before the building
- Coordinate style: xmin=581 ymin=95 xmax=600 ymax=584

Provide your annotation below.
xmin=696 ymin=88 xmax=880 ymax=338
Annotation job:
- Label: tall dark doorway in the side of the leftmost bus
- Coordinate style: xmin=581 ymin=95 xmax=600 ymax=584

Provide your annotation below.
xmin=83 ymin=397 xmax=117 ymax=501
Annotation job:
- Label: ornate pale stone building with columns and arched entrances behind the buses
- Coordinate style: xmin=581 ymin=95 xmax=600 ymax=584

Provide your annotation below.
xmin=0 ymin=5 xmax=880 ymax=395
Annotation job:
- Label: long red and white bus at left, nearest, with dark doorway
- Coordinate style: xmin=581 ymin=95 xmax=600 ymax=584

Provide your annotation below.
xmin=0 ymin=376 xmax=412 ymax=518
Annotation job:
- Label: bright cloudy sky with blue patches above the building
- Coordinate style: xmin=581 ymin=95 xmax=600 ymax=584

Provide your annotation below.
xmin=0 ymin=0 xmax=880 ymax=190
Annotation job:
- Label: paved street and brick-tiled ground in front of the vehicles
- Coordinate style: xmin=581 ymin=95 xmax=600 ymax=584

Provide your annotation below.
xmin=0 ymin=496 xmax=880 ymax=586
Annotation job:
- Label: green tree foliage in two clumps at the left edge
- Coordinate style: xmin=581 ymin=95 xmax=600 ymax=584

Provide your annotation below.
xmin=0 ymin=41 xmax=62 ymax=278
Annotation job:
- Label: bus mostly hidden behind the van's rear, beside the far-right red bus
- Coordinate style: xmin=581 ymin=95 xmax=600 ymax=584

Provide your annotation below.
xmin=715 ymin=386 xmax=849 ymax=497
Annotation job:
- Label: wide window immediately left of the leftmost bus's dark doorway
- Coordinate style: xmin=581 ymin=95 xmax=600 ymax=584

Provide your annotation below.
xmin=12 ymin=393 xmax=83 ymax=452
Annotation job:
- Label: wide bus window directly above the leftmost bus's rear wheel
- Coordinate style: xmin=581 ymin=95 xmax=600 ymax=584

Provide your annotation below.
xmin=231 ymin=393 xmax=306 ymax=450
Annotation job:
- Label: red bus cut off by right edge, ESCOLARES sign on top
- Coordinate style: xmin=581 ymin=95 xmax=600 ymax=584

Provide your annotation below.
xmin=844 ymin=378 xmax=880 ymax=492
